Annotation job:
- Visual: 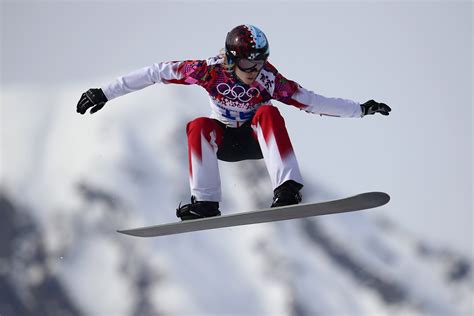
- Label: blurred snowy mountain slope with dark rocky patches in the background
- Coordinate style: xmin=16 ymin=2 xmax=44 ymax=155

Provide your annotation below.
xmin=0 ymin=87 xmax=474 ymax=316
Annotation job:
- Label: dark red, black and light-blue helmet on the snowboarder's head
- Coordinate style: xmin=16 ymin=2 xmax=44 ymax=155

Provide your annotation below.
xmin=225 ymin=24 xmax=270 ymax=63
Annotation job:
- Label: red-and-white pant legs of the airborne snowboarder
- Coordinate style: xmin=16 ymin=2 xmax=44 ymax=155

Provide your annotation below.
xmin=186 ymin=105 xmax=303 ymax=202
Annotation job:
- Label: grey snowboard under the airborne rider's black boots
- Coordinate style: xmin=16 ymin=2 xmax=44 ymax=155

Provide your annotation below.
xmin=118 ymin=192 xmax=390 ymax=237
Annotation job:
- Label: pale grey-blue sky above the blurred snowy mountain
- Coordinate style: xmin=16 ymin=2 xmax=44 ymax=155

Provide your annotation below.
xmin=0 ymin=1 xmax=473 ymax=256
